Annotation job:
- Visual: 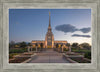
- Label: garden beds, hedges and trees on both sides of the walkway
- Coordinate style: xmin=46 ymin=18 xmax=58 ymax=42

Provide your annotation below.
xmin=9 ymin=42 xmax=91 ymax=63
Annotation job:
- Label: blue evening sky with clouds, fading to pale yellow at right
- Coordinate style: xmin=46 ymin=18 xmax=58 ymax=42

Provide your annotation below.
xmin=9 ymin=9 xmax=91 ymax=44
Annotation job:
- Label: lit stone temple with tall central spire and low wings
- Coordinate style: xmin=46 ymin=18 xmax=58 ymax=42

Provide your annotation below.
xmin=31 ymin=12 xmax=67 ymax=48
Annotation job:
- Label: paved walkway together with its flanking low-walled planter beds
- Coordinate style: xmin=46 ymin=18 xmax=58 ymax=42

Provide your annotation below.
xmin=9 ymin=47 xmax=91 ymax=63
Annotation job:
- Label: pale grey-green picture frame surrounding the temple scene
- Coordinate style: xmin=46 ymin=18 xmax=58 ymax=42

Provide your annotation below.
xmin=3 ymin=3 xmax=97 ymax=69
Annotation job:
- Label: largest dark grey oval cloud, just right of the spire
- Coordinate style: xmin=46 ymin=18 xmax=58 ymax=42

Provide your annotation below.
xmin=55 ymin=24 xmax=78 ymax=33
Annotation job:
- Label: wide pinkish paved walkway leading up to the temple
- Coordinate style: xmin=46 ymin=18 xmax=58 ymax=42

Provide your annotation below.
xmin=29 ymin=49 xmax=69 ymax=63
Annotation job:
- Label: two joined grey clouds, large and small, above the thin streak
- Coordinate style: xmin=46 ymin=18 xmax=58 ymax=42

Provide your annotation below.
xmin=55 ymin=24 xmax=91 ymax=33
